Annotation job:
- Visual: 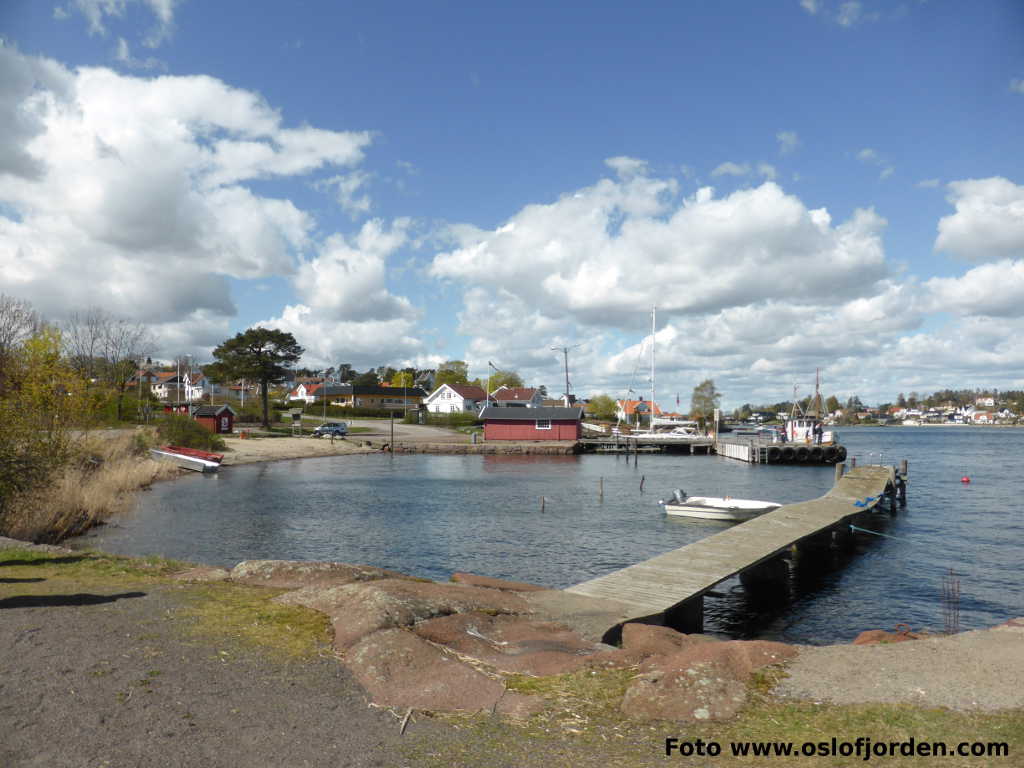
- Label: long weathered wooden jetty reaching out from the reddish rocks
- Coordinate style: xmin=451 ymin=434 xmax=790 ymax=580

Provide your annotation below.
xmin=565 ymin=466 xmax=902 ymax=632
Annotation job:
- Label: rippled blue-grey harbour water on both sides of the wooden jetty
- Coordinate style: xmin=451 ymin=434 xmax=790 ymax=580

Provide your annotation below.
xmin=68 ymin=427 xmax=1024 ymax=643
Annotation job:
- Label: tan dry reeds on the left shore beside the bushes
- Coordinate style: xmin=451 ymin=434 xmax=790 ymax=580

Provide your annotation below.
xmin=2 ymin=434 xmax=178 ymax=543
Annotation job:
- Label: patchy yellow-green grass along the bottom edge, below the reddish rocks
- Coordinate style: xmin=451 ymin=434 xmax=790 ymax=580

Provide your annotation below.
xmin=410 ymin=668 xmax=1024 ymax=768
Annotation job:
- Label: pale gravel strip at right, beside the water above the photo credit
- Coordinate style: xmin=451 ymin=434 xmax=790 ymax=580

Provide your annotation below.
xmin=775 ymin=618 xmax=1024 ymax=711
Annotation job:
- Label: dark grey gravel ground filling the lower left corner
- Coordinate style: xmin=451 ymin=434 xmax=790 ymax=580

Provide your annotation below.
xmin=0 ymin=549 xmax=444 ymax=768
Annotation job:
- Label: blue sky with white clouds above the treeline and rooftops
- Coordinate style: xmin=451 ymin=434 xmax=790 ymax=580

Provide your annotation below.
xmin=0 ymin=0 xmax=1024 ymax=410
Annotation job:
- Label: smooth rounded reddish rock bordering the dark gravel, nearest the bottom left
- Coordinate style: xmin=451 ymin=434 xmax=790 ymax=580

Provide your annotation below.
xmin=344 ymin=629 xmax=543 ymax=716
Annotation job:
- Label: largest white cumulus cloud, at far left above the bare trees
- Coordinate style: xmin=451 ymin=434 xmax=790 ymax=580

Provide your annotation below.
xmin=0 ymin=48 xmax=385 ymax=358
